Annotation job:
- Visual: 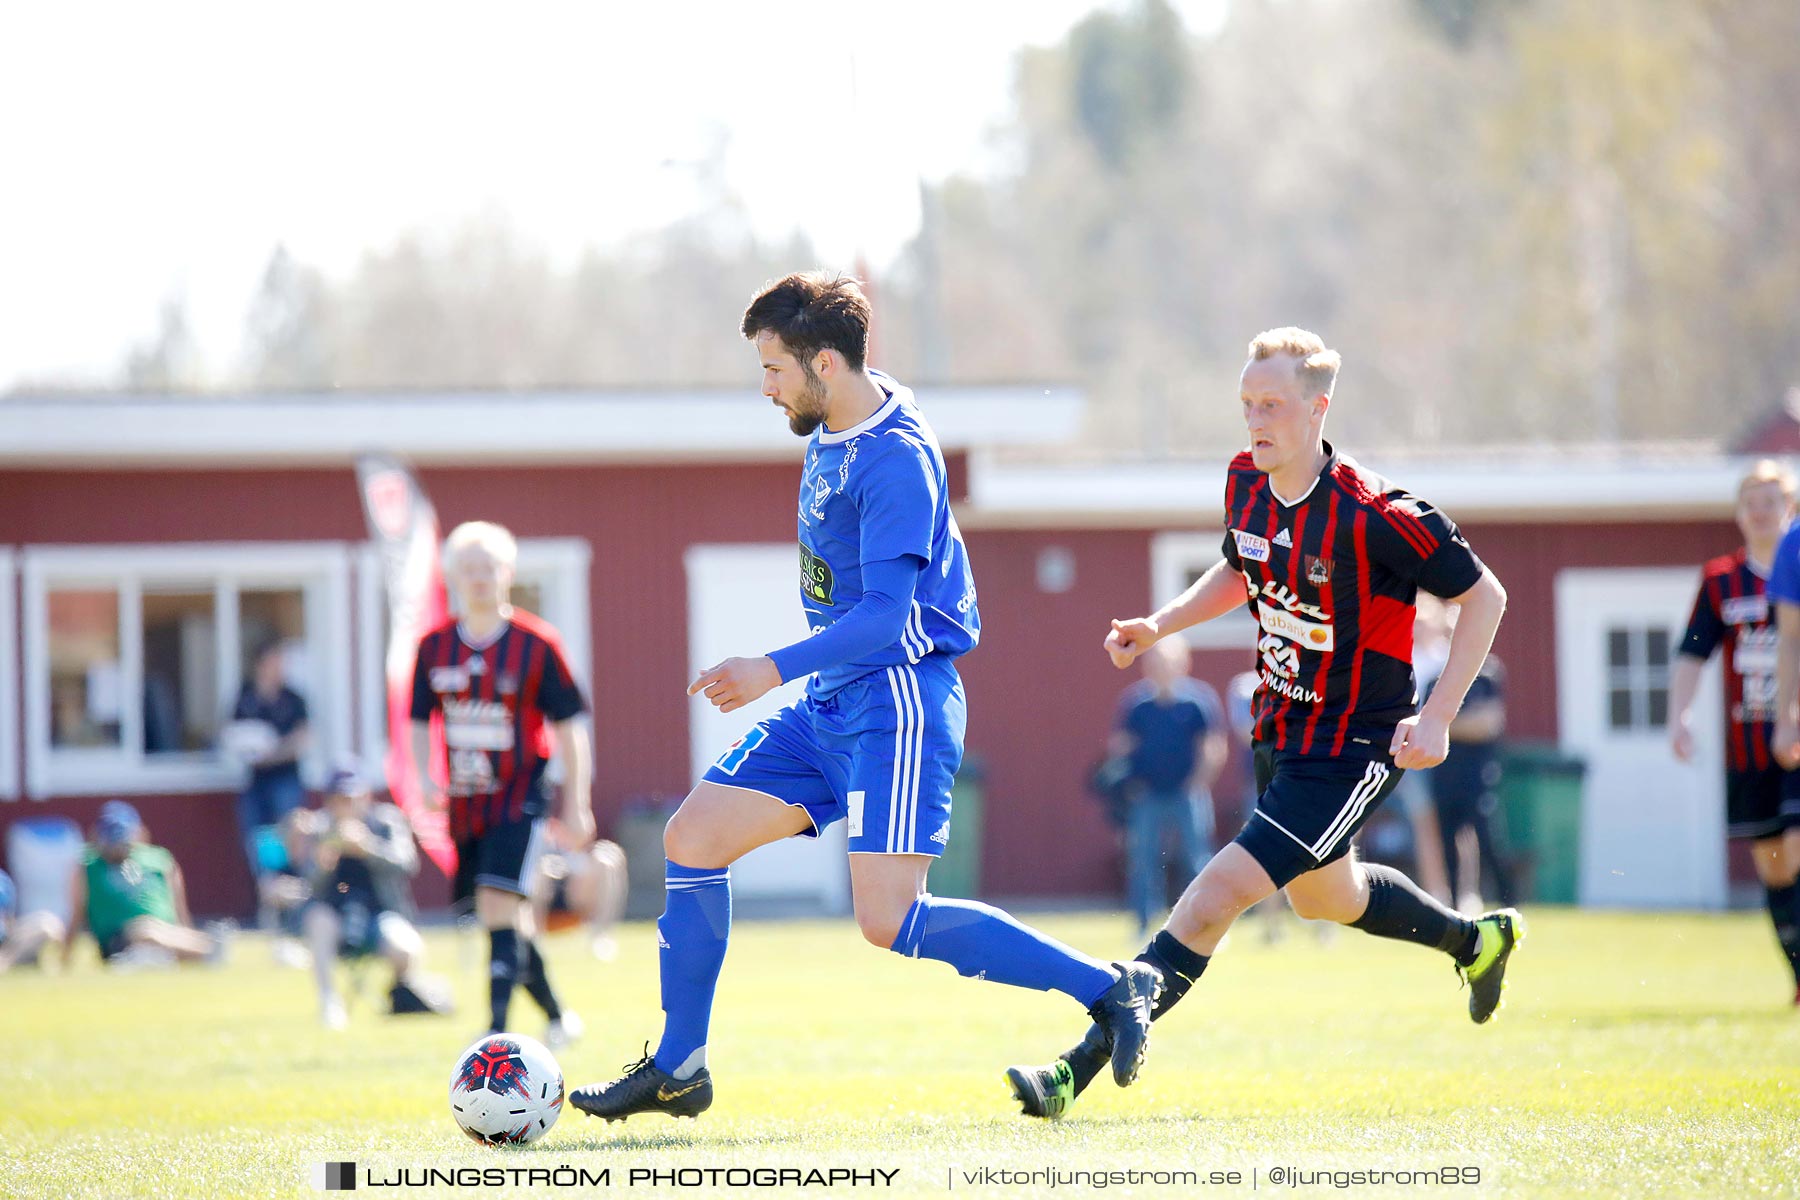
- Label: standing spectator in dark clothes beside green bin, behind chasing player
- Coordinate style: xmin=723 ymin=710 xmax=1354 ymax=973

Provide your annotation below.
xmin=1426 ymin=633 xmax=1517 ymax=912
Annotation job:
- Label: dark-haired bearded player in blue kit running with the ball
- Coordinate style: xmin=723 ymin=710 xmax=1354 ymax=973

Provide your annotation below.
xmin=569 ymin=273 xmax=1159 ymax=1121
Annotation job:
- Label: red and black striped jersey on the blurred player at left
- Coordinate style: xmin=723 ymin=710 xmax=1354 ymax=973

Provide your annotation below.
xmin=412 ymin=608 xmax=587 ymax=842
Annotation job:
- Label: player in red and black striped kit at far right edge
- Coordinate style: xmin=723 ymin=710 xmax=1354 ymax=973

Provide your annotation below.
xmin=1669 ymin=461 xmax=1800 ymax=1004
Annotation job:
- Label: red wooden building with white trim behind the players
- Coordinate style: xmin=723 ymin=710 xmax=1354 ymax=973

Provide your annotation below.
xmin=0 ymin=387 xmax=1746 ymax=912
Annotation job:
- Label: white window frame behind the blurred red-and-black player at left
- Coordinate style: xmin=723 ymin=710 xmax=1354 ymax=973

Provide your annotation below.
xmin=356 ymin=538 xmax=594 ymax=774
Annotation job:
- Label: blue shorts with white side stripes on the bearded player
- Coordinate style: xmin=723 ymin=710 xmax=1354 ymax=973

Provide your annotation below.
xmin=706 ymin=655 xmax=968 ymax=855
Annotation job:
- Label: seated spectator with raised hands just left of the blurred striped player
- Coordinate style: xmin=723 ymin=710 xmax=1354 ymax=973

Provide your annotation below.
xmin=290 ymin=770 xmax=448 ymax=1029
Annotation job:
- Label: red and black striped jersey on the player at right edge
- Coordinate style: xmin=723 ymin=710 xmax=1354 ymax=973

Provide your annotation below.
xmin=1681 ymin=549 xmax=1777 ymax=770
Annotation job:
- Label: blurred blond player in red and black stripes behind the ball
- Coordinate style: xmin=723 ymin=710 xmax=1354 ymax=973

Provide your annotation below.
xmin=412 ymin=522 xmax=594 ymax=1049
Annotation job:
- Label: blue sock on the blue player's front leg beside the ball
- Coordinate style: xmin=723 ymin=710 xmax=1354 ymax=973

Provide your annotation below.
xmin=657 ymin=862 xmax=731 ymax=1078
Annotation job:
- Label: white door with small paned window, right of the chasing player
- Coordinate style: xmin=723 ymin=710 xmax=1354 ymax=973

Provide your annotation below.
xmin=1555 ymin=567 xmax=1726 ymax=909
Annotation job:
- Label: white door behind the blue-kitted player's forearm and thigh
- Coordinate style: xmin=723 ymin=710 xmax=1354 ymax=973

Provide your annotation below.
xmin=684 ymin=542 xmax=850 ymax=912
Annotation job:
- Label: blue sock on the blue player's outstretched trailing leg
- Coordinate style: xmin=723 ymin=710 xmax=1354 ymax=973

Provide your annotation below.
xmin=893 ymin=896 xmax=1118 ymax=1007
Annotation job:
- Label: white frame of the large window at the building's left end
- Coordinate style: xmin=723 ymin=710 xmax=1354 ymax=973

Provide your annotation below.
xmin=20 ymin=542 xmax=351 ymax=799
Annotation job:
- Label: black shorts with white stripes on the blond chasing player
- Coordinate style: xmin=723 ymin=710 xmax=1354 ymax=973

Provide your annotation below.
xmin=1233 ymin=741 xmax=1406 ymax=887
